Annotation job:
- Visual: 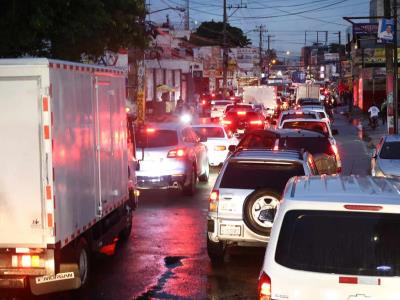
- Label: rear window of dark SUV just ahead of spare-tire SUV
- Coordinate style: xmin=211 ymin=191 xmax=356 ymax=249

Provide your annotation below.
xmin=279 ymin=137 xmax=334 ymax=155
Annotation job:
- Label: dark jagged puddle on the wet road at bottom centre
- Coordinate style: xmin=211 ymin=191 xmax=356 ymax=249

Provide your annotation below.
xmin=136 ymin=256 xmax=187 ymax=300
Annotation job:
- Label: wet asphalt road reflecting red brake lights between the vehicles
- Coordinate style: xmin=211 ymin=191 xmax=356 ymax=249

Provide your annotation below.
xmin=0 ymin=108 xmax=369 ymax=300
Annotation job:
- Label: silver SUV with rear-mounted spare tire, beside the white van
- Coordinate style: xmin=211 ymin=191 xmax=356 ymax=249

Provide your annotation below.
xmin=207 ymin=149 xmax=318 ymax=262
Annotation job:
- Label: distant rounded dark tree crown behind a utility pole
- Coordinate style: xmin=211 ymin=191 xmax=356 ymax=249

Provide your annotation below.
xmin=195 ymin=21 xmax=251 ymax=47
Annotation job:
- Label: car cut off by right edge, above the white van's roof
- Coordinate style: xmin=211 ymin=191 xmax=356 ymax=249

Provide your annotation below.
xmin=371 ymin=135 xmax=400 ymax=178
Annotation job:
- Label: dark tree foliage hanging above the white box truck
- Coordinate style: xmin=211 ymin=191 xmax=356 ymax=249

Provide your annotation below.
xmin=0 ymin=0 xmax=146 ymax=60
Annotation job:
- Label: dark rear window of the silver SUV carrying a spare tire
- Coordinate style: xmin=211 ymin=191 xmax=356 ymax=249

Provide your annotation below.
xmin=220 ymin=161 xmax=304 ymax=193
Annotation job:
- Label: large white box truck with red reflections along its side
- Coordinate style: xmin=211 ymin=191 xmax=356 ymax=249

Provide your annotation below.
xmin=0 ymin=59 xmax=137 ymax=295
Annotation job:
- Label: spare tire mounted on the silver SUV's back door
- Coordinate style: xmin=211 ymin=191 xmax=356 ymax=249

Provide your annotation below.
xmin=243 ymin=189 xmax=281 ymax=236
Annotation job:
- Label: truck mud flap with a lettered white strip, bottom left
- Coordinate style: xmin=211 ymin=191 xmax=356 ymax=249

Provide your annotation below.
xmin=29 ymin=264 xmax=81 ymax=296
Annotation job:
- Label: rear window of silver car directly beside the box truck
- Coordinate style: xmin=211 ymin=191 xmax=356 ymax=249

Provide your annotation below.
xmin=136 ymin=128 xmax=178 ymax=148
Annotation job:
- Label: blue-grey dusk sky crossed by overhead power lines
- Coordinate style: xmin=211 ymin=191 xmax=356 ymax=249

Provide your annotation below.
xmin=147 ymin=0 xmax=369 ymax=56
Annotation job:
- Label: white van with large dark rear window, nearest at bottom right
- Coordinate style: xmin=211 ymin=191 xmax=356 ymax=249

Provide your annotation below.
xmin=259 ymin=176 xmax=400 ymax=300
